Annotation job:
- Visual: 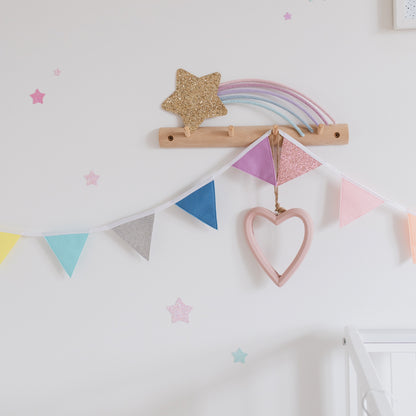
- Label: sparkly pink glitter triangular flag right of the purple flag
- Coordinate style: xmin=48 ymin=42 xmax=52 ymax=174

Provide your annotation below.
xmin=277 ymin=139 xmax=321 ymax=185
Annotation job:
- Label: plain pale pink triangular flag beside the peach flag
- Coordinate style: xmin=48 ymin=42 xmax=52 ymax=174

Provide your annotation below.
xmin=339 ymin=178 xmax=384 ymax=227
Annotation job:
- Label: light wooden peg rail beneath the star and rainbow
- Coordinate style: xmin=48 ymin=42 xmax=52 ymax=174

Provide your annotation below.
xmin=159 ymin=124 xmax=349 ymax=147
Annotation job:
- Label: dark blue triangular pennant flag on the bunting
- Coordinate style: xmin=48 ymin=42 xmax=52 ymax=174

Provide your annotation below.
xmin=176 ymin=181 xmax=218 ymax=229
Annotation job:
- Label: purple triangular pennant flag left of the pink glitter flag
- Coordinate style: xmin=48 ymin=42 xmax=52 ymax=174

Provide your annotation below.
xmin=233 ymin=137 xmax=276 ymax=185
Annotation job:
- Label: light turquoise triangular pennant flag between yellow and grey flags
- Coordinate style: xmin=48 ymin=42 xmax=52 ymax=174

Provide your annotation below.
xmin=45 ymin=234 xmax=88 ymax=277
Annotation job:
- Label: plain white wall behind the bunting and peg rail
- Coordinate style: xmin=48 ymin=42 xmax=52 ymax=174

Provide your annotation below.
xmin=0 ymin=0 xmax=416 ymax=416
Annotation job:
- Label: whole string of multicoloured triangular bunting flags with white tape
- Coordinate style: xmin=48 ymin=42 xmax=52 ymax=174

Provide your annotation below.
xmin=0 ymin=128 xmax=416 ymax=276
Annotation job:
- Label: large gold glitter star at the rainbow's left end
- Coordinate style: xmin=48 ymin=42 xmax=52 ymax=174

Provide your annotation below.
xmin=162 ymin=69 xmax=227 ymax=131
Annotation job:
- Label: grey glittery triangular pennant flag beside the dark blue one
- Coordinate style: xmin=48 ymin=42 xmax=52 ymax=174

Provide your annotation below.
xmin=113 ymin=214 xmax=155 ymax=260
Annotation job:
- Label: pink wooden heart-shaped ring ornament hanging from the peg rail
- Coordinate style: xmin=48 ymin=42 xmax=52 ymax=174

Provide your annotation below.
xmin=244 ymin=207 xmax=313 ymax=287
